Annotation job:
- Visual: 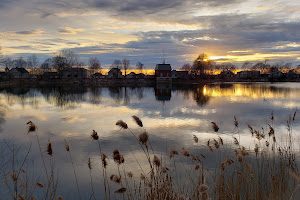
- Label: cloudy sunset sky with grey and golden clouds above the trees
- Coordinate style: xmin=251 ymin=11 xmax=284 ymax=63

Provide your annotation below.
xmin=0 ymin=0 xmax=300 ymax=68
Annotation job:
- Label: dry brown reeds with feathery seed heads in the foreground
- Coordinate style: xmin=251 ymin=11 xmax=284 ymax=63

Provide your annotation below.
xmin=0 ymin=112 xmax=300 ymax=200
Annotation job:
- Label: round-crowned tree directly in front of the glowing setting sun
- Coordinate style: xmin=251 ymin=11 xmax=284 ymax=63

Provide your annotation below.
xmin=192 ymin=53 xmax=213 ymax=75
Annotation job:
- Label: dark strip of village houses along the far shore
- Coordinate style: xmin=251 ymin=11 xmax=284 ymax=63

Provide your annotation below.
xmin=0 ymin=63 xmax=300 ymax=83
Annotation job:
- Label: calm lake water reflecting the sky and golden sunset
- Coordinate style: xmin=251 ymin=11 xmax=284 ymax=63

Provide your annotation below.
xmin=0 ymin=83 xmax=300 ymax=199
